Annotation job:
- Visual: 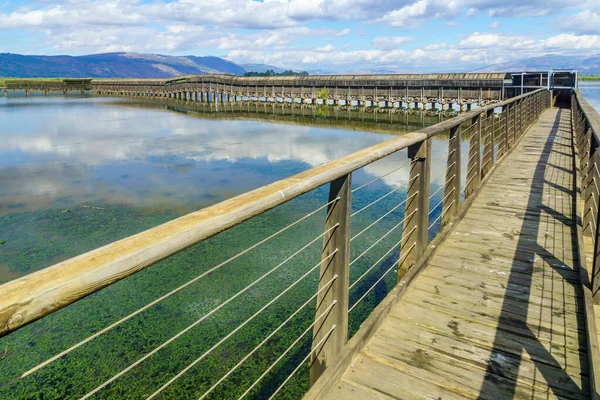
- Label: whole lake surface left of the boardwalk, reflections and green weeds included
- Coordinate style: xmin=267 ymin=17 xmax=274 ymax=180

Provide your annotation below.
xmin=0 ymin=97 xmax=460 ymax=399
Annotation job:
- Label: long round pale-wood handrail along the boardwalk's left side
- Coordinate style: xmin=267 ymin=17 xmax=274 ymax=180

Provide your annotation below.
xmin=0 ymin=89 xmax=546 ymax=337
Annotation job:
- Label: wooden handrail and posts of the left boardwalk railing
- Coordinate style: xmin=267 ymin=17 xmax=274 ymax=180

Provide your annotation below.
xmin=0 ymin=89 xmax=551 ymax=398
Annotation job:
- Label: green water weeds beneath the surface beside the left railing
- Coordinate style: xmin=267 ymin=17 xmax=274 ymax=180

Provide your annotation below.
xmin=0 ymin=180 xmax=437 ymax=399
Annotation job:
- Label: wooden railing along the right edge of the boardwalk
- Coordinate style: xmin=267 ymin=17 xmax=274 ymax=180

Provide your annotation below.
xmin=571 ymin=90 xmax=600 ymax=304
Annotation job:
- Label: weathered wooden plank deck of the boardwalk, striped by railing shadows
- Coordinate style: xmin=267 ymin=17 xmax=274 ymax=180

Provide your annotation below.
xmin=327 ymin=108 xmax=589 ymax=399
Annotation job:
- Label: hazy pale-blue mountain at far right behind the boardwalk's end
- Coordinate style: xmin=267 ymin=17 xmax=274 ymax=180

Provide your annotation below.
xmin=475 ymin=54 xmax=600 ymax=75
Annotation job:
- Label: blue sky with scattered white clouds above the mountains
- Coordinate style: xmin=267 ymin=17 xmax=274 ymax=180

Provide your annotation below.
xmin=0 ymin=0 xmax=600 ymax=72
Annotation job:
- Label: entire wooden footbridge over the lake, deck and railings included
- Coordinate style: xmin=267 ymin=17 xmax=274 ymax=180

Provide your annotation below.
xmin=0 ymin=75 xmax=600 ymax=399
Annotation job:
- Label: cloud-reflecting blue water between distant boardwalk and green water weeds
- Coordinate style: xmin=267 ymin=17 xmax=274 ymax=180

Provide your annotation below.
xmin=0 ymin=97 xmax=398 ymax=219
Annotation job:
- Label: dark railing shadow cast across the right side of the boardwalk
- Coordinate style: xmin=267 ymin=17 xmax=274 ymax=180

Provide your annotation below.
xmin=480 ymin=110 xmax=589 ymax=399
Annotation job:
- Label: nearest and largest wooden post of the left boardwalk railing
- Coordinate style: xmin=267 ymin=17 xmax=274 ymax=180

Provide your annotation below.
xmin=310 ymin=174 xmax=352 ymax=385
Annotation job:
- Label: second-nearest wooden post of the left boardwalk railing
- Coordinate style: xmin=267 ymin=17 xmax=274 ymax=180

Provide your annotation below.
xmin=398 ymin=139 xmax=431 ymax=281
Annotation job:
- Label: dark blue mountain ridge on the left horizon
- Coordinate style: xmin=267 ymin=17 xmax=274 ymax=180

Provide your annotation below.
xmin=0 ymin=53 xmax=246 ymax=78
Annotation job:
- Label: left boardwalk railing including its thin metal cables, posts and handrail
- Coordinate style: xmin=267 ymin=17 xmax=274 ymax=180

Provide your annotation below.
xmin=0 ymin=89 xmax=552 ymax=399
